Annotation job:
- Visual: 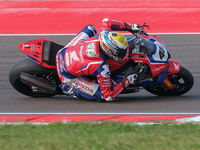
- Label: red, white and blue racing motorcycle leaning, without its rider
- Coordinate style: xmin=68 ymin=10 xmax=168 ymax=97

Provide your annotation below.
xmin=9 ymin=23 xmax=194 ymax=97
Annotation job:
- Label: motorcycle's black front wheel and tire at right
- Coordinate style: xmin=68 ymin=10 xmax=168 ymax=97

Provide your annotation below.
xmin=145 ymin=67 xmax=194 ymax=96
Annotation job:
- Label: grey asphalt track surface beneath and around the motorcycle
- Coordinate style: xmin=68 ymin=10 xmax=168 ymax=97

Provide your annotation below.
xmin=0 ymin=34 xmax=200 ymax=114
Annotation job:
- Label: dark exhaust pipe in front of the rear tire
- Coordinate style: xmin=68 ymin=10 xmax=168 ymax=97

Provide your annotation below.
xmin=20 ymin=72 xmax=56 ymax=93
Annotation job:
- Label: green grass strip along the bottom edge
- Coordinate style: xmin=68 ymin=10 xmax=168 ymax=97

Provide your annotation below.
xmin=0 ymin=122 xmax=200 ymax=150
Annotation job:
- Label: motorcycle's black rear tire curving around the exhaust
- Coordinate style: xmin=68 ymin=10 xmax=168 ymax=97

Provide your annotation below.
xmin=9 ymin=59 xmax=55 ymax=97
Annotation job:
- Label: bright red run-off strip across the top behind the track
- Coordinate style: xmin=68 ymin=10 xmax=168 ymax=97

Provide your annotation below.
xmin=0 ymin=0 xmax=200 ymax=34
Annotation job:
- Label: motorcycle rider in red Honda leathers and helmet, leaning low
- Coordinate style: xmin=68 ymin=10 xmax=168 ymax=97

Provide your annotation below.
xmin=56 ymin=18 xmax=140 ymax=101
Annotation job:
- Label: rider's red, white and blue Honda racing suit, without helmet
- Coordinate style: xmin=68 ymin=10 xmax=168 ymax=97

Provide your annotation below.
xmin=56 ymin=18 xmax=134 ymax=101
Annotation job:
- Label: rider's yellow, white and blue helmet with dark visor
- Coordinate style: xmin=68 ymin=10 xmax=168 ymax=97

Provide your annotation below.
xmin=99 ymin=32 xmax=128 ymax=61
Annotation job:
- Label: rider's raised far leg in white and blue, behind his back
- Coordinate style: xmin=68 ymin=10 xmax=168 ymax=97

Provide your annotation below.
xmin=65 ymin=25 xmax=97 ymax=48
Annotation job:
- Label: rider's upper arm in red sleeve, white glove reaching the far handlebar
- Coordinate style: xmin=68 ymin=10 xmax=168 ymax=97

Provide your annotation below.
xmin=100 ymin=18 xmax=140 ymax=33
